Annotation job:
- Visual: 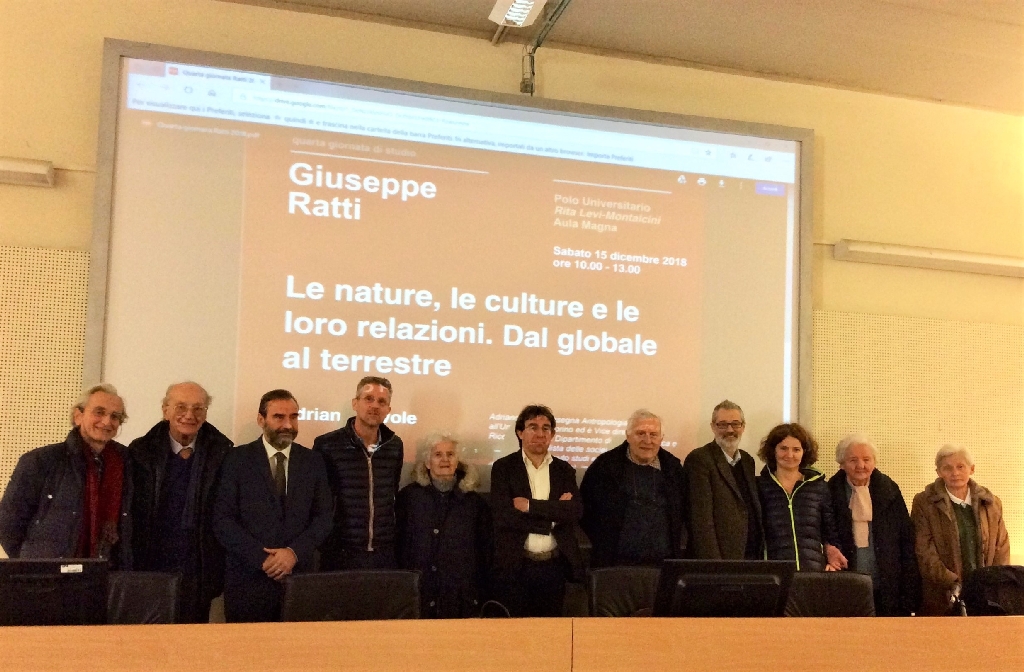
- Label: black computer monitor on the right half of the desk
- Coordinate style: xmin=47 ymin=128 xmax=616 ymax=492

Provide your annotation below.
xmin=653 ymin=560 xmax=797 ymax=618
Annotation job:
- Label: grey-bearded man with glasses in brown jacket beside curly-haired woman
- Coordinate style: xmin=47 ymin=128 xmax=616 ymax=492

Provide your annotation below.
xmin=683 ymin=400 xmax=764 ymax=560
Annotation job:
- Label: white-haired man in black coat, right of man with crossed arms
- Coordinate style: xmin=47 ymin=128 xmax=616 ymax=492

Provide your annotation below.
xmin=580 ymin=410 xmax=686 ymax=569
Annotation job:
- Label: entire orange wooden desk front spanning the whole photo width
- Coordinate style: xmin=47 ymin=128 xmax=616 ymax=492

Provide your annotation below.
xmin=0 ymin=617 xmax=1024 ymax=672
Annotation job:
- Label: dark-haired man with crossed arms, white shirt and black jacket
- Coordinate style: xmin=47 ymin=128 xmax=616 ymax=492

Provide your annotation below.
xmin=490 ymin=406 xmax=583 ymax=617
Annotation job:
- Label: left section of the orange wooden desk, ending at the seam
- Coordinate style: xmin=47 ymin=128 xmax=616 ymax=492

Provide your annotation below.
xmin=0 ymin=619 xmax=572 ymax=672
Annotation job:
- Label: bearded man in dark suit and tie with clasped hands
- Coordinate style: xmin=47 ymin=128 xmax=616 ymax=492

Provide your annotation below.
xmin=213 ymin=389 xmax=333 ymax=623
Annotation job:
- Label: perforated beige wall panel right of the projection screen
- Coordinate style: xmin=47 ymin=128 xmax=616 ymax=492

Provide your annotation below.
xmin=814 ymin=310 xmax=1024 ymax=563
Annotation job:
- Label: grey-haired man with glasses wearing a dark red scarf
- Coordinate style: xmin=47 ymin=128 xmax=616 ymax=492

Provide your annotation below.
xmin=0 ymin=383 xmax=132 ymax=570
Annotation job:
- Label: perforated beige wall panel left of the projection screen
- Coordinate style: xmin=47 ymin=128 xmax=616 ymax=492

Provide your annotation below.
xmin=0 ymin=247 xmax=89 ymax=491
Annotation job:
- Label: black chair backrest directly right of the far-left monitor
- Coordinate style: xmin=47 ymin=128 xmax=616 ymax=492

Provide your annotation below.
xmin=106 ymin=572 xmax=181 ymax=625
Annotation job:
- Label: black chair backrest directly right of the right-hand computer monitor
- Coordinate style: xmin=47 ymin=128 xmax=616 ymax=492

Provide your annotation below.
xmin=785 ymin=572 xmax=874 ymax=618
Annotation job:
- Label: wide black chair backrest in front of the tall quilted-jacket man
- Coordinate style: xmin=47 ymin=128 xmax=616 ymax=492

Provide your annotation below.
xmin=281 ymin=570 xmax=420 ymax=621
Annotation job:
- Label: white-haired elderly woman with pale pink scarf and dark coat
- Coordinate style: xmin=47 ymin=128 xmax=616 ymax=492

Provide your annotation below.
xmin=828 ymin=434 xmax=921 ymax=616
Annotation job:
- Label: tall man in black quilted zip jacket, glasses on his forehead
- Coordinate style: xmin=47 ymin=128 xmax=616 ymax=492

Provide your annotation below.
xmin=313 ymin=376 xmax=406 ymax=571
